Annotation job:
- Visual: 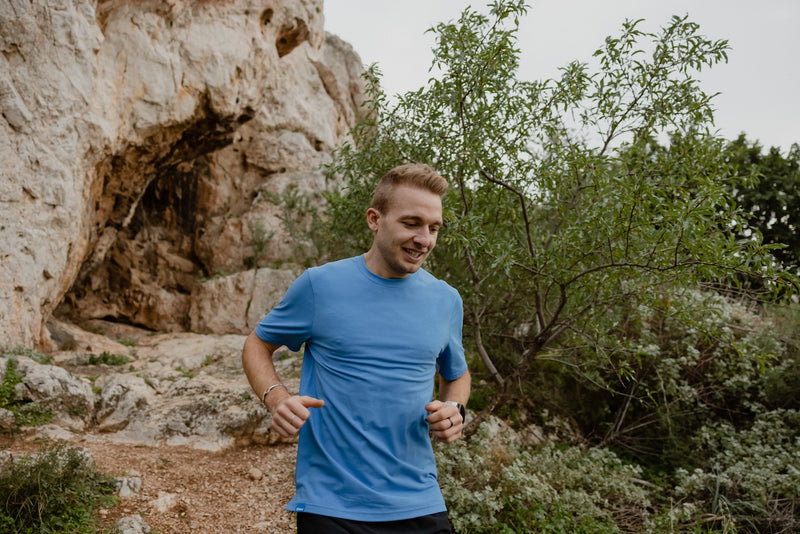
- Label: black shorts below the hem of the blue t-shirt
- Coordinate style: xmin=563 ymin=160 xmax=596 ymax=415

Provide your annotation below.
xmin=297 ymin=512 xmax=452 ymax=534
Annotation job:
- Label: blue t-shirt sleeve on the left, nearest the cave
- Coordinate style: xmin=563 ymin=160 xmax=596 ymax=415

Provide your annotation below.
xmin=255 ymin=271 xmax=314 ymax=351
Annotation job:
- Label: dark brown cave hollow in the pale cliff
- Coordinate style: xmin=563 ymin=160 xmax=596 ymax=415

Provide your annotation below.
xmin=56 ymin=113 xmax=247 ymax=331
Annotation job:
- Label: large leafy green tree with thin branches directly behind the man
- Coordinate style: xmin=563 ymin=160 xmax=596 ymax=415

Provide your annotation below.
xmin=328 ymin=1 xmax=796 ymax=444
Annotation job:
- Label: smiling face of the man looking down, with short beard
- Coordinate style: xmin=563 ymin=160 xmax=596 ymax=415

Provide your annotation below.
xmin=367 ymin=185 xmax=442 ymax=278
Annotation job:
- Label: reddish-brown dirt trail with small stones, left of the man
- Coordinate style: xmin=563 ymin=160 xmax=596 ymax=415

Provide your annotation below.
xmin=0 ymin=436 xmax=296 ymax=534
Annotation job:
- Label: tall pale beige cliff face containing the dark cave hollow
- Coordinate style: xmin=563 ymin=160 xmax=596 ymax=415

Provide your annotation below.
xmin=0 ymin=0 xmax=363 ymax=350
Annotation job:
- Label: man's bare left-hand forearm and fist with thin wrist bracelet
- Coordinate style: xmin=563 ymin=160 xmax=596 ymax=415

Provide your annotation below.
xmin=242 ymin=332 xmax=325 ymax=438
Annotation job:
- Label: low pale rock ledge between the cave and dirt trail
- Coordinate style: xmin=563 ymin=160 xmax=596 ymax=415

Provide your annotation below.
xmin=0 ymin=321 xmax=302 ymax=451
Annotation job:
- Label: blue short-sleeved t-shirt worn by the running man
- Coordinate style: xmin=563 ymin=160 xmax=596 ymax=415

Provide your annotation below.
xmin=255 ymin=256 xmax=467 ymax=521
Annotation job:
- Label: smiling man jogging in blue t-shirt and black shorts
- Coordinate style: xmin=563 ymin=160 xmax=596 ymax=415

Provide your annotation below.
xmin=242 ymin=164 xmax=470 ymax=534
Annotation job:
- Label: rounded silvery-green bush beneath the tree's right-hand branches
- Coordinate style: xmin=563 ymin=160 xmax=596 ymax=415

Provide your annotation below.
xmin=559 ymin=291 xmax=787 ymax=465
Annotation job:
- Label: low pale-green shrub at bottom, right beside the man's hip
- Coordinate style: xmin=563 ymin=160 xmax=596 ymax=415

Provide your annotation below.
xmin=436 ymin=422 xmax=650 ymax=534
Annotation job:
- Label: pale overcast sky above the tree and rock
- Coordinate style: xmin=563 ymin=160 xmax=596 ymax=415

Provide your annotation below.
xmin=324 ymin=0 xmax=800 ymax=154
